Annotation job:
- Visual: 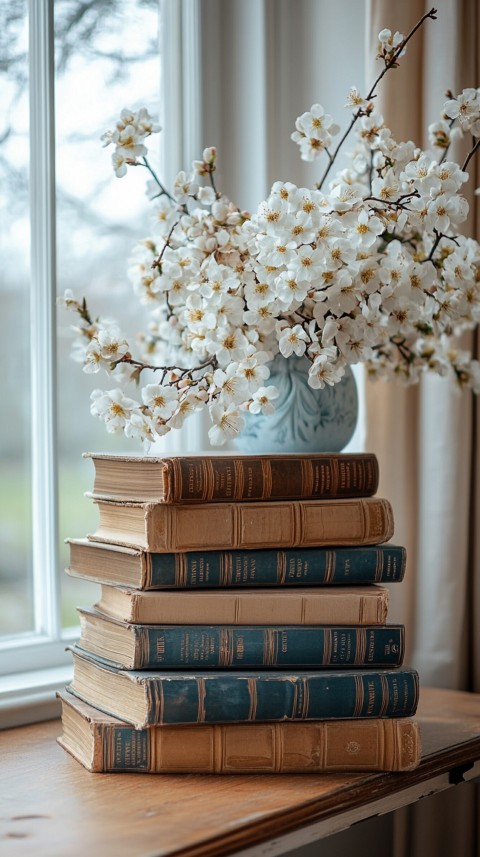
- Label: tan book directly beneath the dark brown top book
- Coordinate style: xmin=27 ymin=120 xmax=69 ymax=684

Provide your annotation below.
xmin=88 ymin=497 xmax=393 ymax=553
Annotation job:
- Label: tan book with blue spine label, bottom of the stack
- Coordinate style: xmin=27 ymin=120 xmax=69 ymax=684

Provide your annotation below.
xmin=57 ymin=692 xmax=421 ymax=774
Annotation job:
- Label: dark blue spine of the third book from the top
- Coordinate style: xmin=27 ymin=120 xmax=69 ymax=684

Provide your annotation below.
xmin=144 ymin=544 xmax=406 ymax=589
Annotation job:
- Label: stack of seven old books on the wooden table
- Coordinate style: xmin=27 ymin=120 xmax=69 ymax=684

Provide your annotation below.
xmin=59 ymin=453 xmax=420 ymax=773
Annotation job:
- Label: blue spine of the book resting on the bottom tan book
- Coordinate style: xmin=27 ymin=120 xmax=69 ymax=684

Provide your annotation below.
xmin=145 ymin=669 xmax=418 ymax=726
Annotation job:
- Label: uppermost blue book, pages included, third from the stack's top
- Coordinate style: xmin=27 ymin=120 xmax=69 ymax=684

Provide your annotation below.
xmin=66 ymin=539 xmax=406 ymax=589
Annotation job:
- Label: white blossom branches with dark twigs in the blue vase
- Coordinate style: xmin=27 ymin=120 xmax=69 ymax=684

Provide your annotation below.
xmin=62 ymin=9 xmax=480 ymax=449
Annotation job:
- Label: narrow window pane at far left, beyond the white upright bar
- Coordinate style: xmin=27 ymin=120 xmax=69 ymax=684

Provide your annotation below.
xmin=0 ymin=0 xmax=33 ymax=635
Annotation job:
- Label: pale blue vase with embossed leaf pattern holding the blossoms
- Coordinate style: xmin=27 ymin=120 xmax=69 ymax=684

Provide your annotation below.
xmin=235 ymin=354 xmax=358 ymax=455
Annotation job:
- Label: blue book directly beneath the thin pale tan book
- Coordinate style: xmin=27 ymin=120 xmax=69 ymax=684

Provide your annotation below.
xmin=78 ymin=608 xmax=405 ymax=670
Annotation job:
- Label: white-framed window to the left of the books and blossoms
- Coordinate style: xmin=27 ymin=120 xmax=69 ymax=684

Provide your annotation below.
xmin=0 ymin=0 xmax=165 ymax=724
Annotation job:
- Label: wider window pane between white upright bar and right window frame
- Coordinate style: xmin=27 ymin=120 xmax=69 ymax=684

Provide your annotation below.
xmin=55 ymin=0 xmax=160 ymax=627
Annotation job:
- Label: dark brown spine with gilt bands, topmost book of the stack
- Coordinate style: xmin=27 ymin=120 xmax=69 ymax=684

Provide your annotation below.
xmin=163 ymin=453 xmax=378 ymax=503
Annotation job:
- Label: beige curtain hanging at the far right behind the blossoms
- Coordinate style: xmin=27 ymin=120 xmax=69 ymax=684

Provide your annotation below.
xmin=366 ymin=0 xmax=480 ymax=857
